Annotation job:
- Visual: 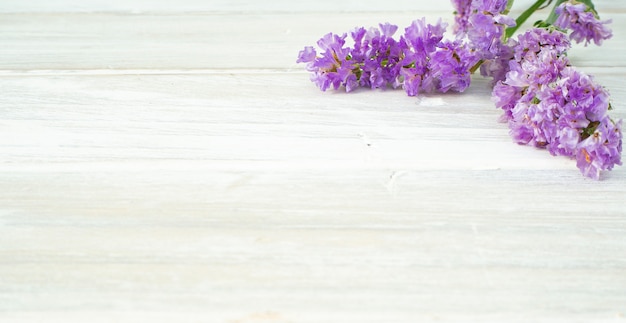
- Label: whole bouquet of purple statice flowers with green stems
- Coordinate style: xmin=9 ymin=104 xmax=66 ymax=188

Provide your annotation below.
xmin=297 ymin=0 xmax=622 ymax=179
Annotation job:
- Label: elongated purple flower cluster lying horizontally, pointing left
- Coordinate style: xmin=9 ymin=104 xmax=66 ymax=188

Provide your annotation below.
xmin=297 ymin=18 xmax=478 ymax=96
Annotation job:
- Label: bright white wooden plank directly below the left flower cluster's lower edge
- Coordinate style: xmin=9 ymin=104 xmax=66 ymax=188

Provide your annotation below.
xmin=0 ymin=69 xmax=625 ymax=170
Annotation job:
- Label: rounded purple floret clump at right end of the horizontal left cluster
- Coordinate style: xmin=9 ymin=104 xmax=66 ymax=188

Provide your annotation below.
xmin=429 ymin=40 xmax=478 ymax=93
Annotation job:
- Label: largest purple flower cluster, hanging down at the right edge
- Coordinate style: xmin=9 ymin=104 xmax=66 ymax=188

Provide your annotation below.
xmin=492 ymin=28 xmax=622 ymax=179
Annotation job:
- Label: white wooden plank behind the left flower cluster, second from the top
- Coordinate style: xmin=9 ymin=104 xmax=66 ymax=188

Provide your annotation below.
xmin=0 ymin=12 xmax=626 ymax=71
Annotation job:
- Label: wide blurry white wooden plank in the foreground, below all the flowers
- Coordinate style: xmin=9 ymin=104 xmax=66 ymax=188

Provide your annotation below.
xmin=0 ymin=170 xmax=626 ymax=322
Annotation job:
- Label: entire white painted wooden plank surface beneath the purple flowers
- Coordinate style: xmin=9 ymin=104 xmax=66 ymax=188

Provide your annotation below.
xmin=0 ymin=0 xmax=626 ymax=323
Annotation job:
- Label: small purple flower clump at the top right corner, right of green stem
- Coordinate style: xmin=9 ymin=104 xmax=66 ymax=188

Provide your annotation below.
xmin=554 ymin=1 xmax=613 ymax=46
